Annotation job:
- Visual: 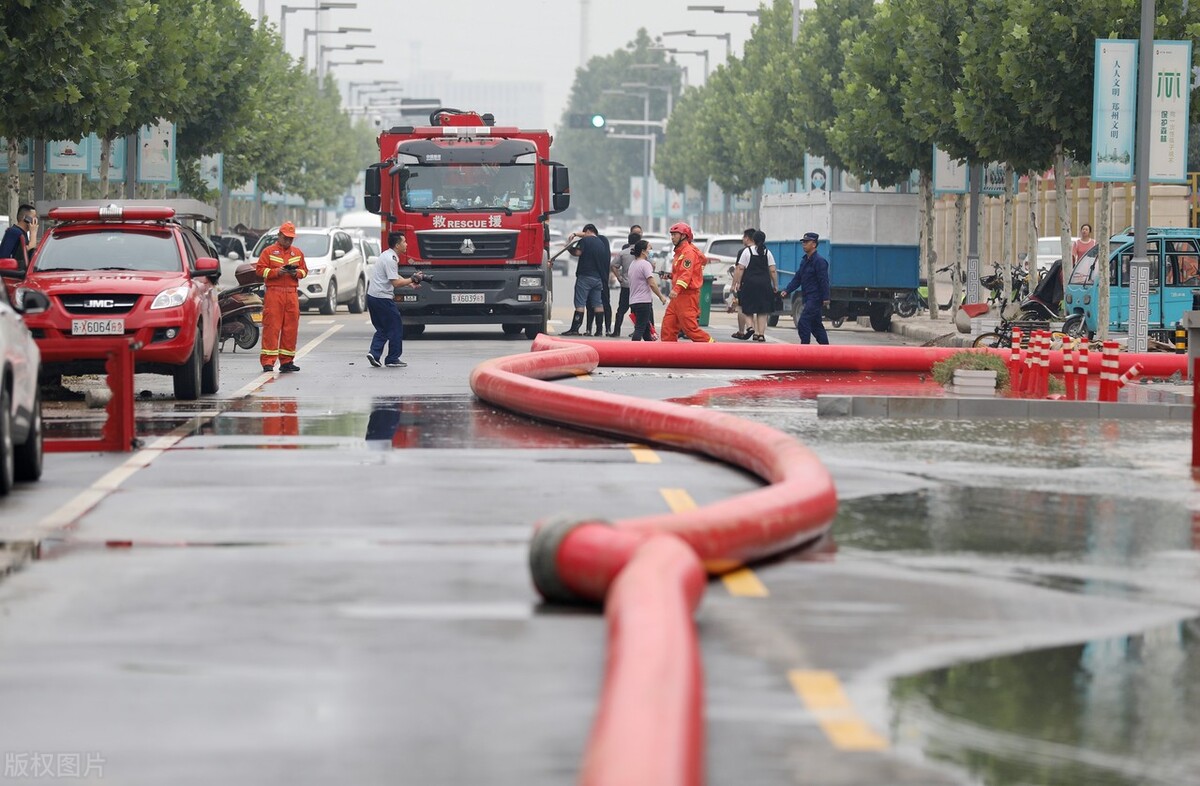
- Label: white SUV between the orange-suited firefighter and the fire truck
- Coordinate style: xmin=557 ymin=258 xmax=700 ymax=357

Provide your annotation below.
xmin=253 ymin=227 xmax=367 ymax=314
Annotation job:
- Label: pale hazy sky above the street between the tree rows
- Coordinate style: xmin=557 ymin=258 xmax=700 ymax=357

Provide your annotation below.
xmin=241 ymin=0 xmax=758 ymax=127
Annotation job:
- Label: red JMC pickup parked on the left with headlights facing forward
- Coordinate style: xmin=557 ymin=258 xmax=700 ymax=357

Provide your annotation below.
xmin=4 ymin=200 xmax=221 ymax=401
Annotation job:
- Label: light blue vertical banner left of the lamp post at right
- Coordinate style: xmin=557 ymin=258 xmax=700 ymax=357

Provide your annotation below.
xmin=1091 ymin=38 xmax=1138 ymax=182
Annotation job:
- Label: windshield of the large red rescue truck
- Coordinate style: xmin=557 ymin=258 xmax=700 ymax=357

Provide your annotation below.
xmin=400 ymin=163 xmax=535 ymax=214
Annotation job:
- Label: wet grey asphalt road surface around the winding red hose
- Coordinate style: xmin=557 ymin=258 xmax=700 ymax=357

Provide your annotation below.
xmin=0 ymin=284 xmax=1200 ymax=786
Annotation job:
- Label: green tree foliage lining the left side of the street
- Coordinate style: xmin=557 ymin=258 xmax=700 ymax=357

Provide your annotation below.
xmin=0 ymin=0 xmax=374 ymax=208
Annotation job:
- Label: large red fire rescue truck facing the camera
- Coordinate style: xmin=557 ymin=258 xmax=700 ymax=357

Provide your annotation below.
xmin=364 ymin=108 xmax=571 ymax=338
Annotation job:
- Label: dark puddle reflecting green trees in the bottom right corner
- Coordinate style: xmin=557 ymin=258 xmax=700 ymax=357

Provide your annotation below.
xmin=892 ymin=620 xmax=1200 ymax=786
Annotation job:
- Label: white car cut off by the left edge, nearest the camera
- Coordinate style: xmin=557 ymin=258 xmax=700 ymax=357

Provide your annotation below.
xmin=0 ymin=279 xmax=50 ymax=497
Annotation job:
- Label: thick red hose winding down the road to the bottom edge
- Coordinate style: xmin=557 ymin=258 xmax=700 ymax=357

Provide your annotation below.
xmin=470 ymin=336 xmax=838 ymax=786
